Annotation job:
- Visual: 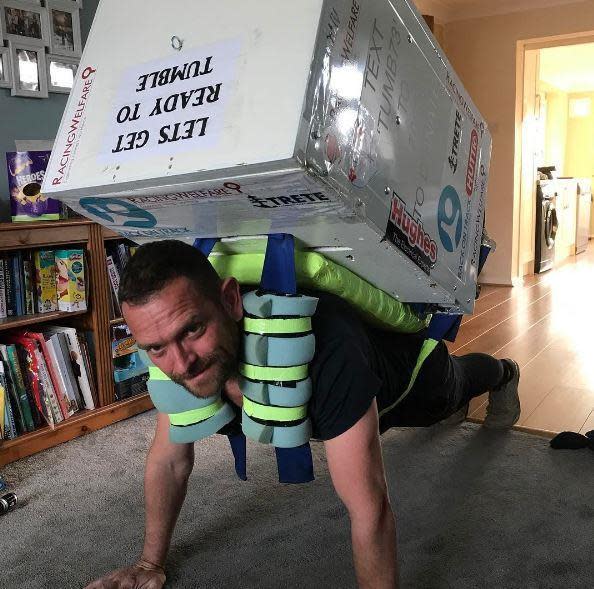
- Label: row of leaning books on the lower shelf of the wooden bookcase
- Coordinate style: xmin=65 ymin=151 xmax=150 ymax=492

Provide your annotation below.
xmin=0 ymin=325 xmax=97 ymax=439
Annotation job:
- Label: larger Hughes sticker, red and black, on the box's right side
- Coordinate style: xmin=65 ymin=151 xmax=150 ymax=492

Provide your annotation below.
xmin=386 ymin=194 xmax=437 ymax=274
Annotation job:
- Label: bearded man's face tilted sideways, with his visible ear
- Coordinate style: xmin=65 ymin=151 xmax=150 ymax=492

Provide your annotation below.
xmin=122 ymin=277 xmax=242 ymax=397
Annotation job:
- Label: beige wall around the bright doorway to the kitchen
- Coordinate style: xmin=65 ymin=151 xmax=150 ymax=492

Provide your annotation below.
xmin=445 ymin=2 xmax=594 ymax=284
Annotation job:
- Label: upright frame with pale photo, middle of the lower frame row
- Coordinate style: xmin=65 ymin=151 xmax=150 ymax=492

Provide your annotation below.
xmin=8 ymin=41 xmax=48 ymax=98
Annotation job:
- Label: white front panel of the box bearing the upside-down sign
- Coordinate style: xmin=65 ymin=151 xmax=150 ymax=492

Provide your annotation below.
xmin=47 ymin=0 xmax=322 ymax=193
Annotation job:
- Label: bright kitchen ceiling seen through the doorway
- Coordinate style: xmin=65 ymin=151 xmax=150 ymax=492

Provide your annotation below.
xmin=540 ymin=43 xmax=594 ymax=93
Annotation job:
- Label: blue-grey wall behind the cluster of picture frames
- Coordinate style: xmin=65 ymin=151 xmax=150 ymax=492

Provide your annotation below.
xmin=0 ymin=0 xmax=99 ymax=221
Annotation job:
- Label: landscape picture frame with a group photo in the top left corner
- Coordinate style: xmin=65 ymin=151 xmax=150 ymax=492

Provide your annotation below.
xmin=0 ymin=0 xmax=49 ymax=47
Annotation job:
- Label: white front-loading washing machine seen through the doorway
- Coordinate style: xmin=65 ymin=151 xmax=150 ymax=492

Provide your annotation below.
xmin=534 ymin=180 xmax=559 ymax=273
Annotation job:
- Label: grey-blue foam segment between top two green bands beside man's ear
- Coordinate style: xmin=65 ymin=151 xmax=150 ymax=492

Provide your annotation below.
xmin=243 ymin=333 xmax=316 ymax=366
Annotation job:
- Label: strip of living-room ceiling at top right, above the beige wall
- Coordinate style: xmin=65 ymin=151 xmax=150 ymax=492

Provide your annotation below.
xmin=412 ymin=0 xmax=587 ymax=23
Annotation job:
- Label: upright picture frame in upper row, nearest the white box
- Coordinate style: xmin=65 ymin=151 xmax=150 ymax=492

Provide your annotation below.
xmin=45 ymin=0 xmax=82 ymax=57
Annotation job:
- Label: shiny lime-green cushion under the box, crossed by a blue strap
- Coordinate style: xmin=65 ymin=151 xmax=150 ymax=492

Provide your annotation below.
xmin=209 ymin=251 xmax=426 ymax=333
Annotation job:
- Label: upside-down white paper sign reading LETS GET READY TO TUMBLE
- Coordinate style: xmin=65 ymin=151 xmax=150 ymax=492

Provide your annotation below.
xmin=100 ymin=41 xmax=240 ymax=163
